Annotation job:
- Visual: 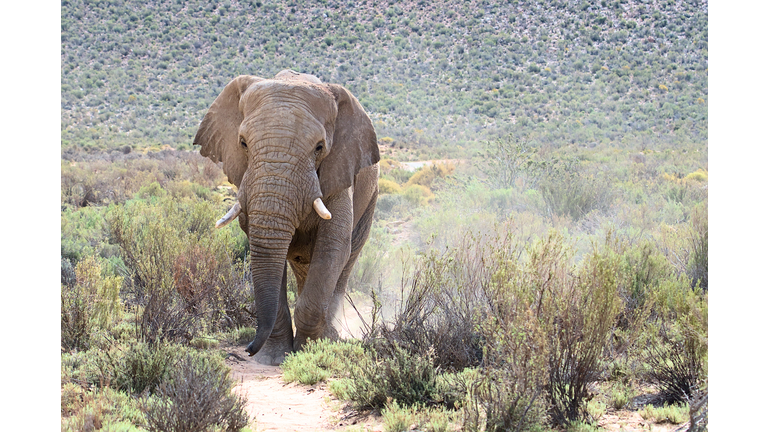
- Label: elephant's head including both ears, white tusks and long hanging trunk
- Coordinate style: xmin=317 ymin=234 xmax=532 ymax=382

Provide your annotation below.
xmin=194 ymin=71 xmax=379 ymax=355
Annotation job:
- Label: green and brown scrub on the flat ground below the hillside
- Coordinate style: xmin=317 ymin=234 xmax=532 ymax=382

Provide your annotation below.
xmin=61 ymin=138 xmax=708 ymax=430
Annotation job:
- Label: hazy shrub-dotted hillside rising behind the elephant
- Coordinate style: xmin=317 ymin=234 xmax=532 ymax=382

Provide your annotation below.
xmin=61 ymin=0 xmax=708 ymax=157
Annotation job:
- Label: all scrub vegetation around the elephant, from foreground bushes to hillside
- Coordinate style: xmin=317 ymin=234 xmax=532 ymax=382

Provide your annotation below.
xmin=61 ymin=0 xmax=708 ymax=431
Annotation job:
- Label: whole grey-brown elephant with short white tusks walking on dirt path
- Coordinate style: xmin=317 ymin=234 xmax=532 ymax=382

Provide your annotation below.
xmin=193 ymin=70 xmax=380 ymax=365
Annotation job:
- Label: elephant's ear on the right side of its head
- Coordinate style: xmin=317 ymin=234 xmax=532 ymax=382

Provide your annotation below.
xmin=318 ymin=84 xmax=380 ymax=197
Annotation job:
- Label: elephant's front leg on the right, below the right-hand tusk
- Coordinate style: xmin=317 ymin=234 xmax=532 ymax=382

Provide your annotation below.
xmin=293 ymin=188 xmax=353 ymax=350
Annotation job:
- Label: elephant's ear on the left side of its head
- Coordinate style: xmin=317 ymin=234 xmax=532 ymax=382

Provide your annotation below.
xmin=192 ymin=75 xmax=263 ymax=187
